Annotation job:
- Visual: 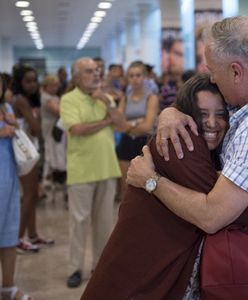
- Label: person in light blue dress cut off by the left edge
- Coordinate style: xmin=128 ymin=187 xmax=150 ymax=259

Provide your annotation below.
xmin=0 ymin=75 xmax=32 ymax=300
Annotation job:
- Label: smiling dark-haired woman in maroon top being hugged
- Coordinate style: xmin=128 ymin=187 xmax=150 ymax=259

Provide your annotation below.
xmin=81 ymin=74 xmax=231 ymax=300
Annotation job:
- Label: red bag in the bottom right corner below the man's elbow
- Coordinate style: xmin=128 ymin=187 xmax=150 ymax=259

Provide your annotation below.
xmin=200 ymin=225 xmax=248 ymax=300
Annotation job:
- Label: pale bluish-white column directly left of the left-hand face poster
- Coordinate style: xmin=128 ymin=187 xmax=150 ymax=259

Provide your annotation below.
xmin=140 ymin=4 xmax=161 ymax=72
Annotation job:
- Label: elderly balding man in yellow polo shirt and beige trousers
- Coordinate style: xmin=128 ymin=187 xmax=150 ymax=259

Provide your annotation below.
xmin=60 ymin=58 xmax=121 ymax=288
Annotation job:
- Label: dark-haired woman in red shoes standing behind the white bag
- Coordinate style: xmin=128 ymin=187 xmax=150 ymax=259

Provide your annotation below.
xmin=13 ymin=65 xmax=54 ymax=254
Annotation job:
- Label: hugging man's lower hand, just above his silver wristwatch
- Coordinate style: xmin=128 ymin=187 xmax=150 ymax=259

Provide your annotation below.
xmin=126 ymin=146 xmax=155 ymax=188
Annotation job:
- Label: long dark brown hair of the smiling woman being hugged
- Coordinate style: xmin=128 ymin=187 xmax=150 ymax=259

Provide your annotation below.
xmin=173 ymin=73 xmax=229 ymax=170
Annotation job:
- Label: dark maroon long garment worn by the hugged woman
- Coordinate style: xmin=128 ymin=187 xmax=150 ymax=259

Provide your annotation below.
xmin=81 ymin=133 xmax=217 ymax=300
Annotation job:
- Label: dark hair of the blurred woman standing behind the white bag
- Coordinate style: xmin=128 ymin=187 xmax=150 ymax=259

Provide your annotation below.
xmin=12 ymin=64 xmax=40 ymax=107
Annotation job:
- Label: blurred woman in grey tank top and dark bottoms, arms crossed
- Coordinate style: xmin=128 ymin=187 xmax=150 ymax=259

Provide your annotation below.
xmin=117 ymin=62 xmax=159 ymax=199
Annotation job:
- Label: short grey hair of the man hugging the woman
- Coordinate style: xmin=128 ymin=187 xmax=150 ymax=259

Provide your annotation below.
xmin=207 ymin=16 xmax=248 ymax=63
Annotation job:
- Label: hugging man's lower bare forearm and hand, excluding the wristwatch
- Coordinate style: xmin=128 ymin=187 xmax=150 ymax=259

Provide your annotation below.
xmin=127 ymin=146 xmax=248 ymax=233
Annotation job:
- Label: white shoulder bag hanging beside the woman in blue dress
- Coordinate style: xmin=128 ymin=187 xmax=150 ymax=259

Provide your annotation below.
xmin=12 ymin=129 xmax=40 ymax=176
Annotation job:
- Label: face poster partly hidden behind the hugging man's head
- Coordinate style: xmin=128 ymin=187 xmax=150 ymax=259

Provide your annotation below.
xmin=195 ymin=9 xmax=223 ymax=72
